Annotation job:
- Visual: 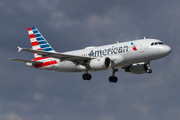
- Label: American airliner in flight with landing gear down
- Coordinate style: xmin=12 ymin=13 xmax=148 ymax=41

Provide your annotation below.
xmin=10 ymin=27 xmax=171 ymax=83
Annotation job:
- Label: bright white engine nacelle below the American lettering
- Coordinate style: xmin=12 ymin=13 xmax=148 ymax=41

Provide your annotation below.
xmin=89 ymin=57 xmax=111 ymax=70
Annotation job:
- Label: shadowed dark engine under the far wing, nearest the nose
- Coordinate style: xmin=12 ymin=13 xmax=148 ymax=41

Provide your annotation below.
xmin=125 ymin=63 xmax=152 ymax=74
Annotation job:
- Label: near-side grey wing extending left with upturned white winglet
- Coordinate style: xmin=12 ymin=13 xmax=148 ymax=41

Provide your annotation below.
xmin=18 ymin=47 xmax=94 ymax=64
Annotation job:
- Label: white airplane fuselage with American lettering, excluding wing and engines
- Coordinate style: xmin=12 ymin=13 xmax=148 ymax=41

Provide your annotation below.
xmin=35 ymin=39 xmax=171 ymax=72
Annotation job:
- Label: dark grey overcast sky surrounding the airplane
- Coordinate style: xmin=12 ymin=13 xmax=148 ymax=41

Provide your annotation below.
xmin=0 ymin=0 xmax=180 ymax=120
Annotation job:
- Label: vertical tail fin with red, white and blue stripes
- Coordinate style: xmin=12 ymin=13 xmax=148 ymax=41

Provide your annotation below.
xmin=28 ymin=27 xmax=55 ymax=59
